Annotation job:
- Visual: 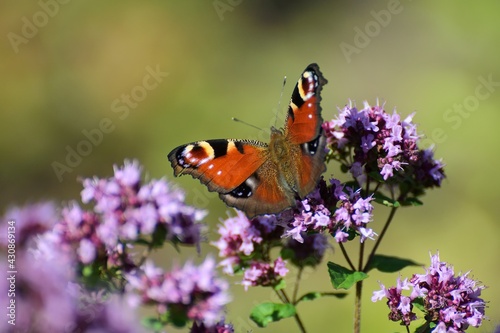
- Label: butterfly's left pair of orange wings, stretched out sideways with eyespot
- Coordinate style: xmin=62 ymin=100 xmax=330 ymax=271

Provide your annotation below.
xmin=168 ymin=139 xmax=294 ymax=217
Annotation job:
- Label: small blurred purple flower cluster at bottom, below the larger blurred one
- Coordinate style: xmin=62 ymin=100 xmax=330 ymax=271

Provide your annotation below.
xmin=126 ymin=257 xmax=230 ymax=326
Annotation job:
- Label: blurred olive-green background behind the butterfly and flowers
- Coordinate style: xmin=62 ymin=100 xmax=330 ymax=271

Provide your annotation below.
xmin=0 ymin=0 xmax=500 ymax=332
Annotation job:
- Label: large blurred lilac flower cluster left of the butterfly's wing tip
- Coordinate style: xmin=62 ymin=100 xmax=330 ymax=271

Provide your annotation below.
xmin=54 ymin=161 xmax=206 ymax=268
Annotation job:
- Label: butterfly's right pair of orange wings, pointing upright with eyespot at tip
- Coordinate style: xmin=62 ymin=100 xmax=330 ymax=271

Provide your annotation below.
xmin=285 ymin=64 xmax=328 ymax=198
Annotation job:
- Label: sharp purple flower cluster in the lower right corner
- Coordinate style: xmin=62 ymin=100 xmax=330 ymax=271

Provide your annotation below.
xmin=372 ymin=254 xmax=486 ymax=332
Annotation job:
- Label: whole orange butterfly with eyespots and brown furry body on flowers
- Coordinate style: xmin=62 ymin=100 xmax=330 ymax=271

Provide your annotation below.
xmin=168 ymin=64 xmax=328 ymax=218
